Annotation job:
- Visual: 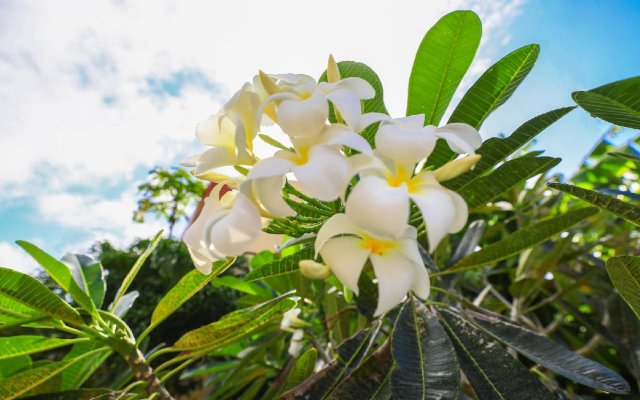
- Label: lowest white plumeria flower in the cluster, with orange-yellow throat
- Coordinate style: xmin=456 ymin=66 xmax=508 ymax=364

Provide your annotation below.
xmin=315 ymin=209 xmax=430 ymax=316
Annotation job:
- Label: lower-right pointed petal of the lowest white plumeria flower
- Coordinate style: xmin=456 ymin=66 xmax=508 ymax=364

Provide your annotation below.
xmin=371 ymin=251 xmax=415 ymax=316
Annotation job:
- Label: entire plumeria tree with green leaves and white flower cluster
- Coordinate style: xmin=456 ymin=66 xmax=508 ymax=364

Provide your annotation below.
xmin=0 ymin=11 xmax=640 ymax=399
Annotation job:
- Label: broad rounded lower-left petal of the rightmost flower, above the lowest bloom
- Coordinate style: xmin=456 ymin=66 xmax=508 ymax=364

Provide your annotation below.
xmin=346 ymin=175 xmax=409 ymax=238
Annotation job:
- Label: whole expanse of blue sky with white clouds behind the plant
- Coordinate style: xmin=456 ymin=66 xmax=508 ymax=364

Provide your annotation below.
xmin=0 ymin=0 xmax=640 ymax=270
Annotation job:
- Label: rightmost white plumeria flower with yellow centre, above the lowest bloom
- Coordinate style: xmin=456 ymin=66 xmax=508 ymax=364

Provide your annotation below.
xmin=346 ymin=115 xmax=482 ymax=251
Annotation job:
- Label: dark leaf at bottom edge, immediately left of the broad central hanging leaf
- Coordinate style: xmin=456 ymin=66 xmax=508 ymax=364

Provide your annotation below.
xmin=281 ymin=329 xmax=372 ymax=400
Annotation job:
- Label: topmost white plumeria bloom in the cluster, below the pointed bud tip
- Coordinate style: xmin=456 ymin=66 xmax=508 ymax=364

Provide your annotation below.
xmin=254 ymin=69 xmax=384 ymax=138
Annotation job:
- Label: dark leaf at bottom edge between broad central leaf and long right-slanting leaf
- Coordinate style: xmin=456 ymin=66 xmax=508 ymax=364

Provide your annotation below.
xmin=441 ymin=310 xmax=555 ymax=400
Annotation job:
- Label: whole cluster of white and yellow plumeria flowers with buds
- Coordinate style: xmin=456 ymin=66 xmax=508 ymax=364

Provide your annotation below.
xmin=183 ymin=57 xmax=481 ymax=315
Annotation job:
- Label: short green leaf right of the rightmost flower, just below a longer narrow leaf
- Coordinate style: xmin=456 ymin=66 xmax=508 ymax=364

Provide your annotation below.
xmin=458 ymin=157 xmax=561 ymax=209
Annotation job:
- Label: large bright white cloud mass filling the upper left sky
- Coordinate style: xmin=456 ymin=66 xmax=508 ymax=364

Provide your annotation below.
xmin=0 ymin=0 xmax=523 ymax=254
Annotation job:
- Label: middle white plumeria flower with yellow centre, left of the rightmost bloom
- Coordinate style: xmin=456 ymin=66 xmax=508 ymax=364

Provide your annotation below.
xmin=242 ymin=124 xmax=371 ymax=217
